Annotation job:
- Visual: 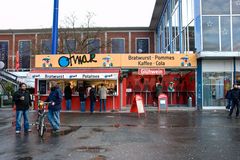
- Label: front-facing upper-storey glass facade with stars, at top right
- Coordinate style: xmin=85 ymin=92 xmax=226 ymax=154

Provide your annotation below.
xmin=201 ymin=0 xmax=240 ymax=52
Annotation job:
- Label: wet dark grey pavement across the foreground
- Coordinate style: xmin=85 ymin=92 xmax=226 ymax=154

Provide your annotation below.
xmin=0 ymin=110 xmax=240 ymax=160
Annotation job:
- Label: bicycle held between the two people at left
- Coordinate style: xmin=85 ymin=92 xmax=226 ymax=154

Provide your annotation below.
xmin=36 ymin=101 xmax=50 ymax=137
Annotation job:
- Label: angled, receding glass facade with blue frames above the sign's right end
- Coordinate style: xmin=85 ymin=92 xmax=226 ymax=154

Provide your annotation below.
xmin=157 ymin=0 xmax=195 ymax=53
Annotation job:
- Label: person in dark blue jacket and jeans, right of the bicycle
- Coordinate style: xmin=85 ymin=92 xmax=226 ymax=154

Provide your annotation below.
xmin=45 ymin=81 xmax=63 ymax=132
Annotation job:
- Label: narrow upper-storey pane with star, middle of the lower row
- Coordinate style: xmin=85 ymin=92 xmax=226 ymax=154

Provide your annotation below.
xmin=221 ymin=16 xmax=231 ymax=51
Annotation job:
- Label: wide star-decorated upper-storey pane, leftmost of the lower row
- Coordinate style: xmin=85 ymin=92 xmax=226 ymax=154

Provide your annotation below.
xmin=202 ymin=16 xmax=219 ymax=51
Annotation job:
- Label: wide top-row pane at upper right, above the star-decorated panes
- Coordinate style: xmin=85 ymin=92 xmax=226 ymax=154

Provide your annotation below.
xmin=202 ymin=0 xmax=230 ymax=15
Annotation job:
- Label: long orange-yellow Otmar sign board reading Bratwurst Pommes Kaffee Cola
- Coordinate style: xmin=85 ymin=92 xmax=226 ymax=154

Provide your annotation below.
xmin=35 ymin=54 xmax=197 ymax=68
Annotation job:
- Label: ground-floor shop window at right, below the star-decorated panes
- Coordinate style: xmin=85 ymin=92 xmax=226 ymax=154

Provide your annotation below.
xmin=203 ymin=72 xmax=232 ymax=106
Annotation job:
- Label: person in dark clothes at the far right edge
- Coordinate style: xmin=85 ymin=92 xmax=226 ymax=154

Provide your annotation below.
xmin=228 ymin=84 xmax=240 ymax=118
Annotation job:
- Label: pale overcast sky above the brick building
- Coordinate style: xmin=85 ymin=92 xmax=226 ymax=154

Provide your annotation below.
xmin=0 ymin=0 xmax=156 ymax=29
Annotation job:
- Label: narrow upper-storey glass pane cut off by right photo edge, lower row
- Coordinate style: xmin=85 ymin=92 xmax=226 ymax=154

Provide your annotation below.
xmin=232 ymin=16 xmax=240 ymax=52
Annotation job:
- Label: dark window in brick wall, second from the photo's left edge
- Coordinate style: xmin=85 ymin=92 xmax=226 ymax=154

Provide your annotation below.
xmin=18 ymin=41 xmax=31 ymax=68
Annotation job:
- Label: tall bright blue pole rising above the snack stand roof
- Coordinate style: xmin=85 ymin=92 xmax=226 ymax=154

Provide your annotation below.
xmin=52 ymin=0 xmax=59 ymax=54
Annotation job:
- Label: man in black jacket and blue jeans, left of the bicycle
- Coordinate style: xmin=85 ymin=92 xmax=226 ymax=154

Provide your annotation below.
xmin=13 ymin=83 xmax=32 ymax=134
